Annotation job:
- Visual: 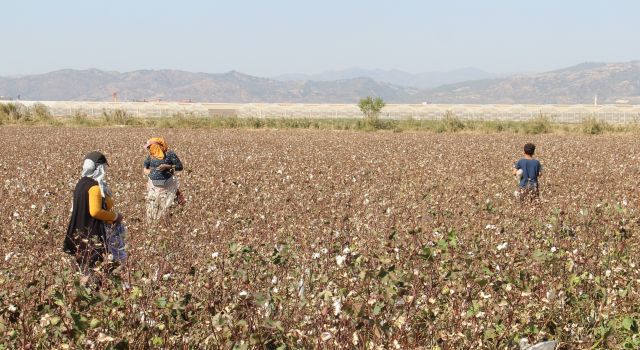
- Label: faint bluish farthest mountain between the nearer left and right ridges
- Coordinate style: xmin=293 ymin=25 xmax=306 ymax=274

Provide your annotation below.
xmin=274 ymin=68 xmax=498 ymax=89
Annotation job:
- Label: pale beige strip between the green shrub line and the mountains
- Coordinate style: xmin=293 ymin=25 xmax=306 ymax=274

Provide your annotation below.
xmin=11 ymin=101 xmax=640 ymax=124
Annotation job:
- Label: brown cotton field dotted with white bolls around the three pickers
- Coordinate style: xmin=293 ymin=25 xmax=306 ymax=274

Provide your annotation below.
xmin=0 ymin=127 xmax=640 ymax=349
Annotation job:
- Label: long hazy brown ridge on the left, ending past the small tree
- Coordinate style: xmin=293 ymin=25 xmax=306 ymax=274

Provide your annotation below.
xmin=0 ymin=69 xmax=417 ymax=103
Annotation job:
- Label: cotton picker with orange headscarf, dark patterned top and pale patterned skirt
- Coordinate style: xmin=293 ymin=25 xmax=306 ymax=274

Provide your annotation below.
xmin=144 ymin=137 xmax=186 ymax=221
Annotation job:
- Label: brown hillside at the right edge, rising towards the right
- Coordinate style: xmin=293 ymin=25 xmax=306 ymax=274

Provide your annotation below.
xmin=424 ymin=61 xmax=640 ymax=104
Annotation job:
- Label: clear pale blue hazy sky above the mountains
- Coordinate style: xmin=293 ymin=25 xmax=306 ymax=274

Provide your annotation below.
xmin=0 ymin=0 xmax=640 ymax=76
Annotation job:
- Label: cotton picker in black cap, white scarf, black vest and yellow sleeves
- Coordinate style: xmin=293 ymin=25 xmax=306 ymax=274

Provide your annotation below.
xmin=63 ymin=151 xmax=127 ymax=281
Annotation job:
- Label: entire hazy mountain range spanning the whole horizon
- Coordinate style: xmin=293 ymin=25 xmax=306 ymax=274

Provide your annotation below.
xmin=0 ymin=61 xmax=640 ymax=104
